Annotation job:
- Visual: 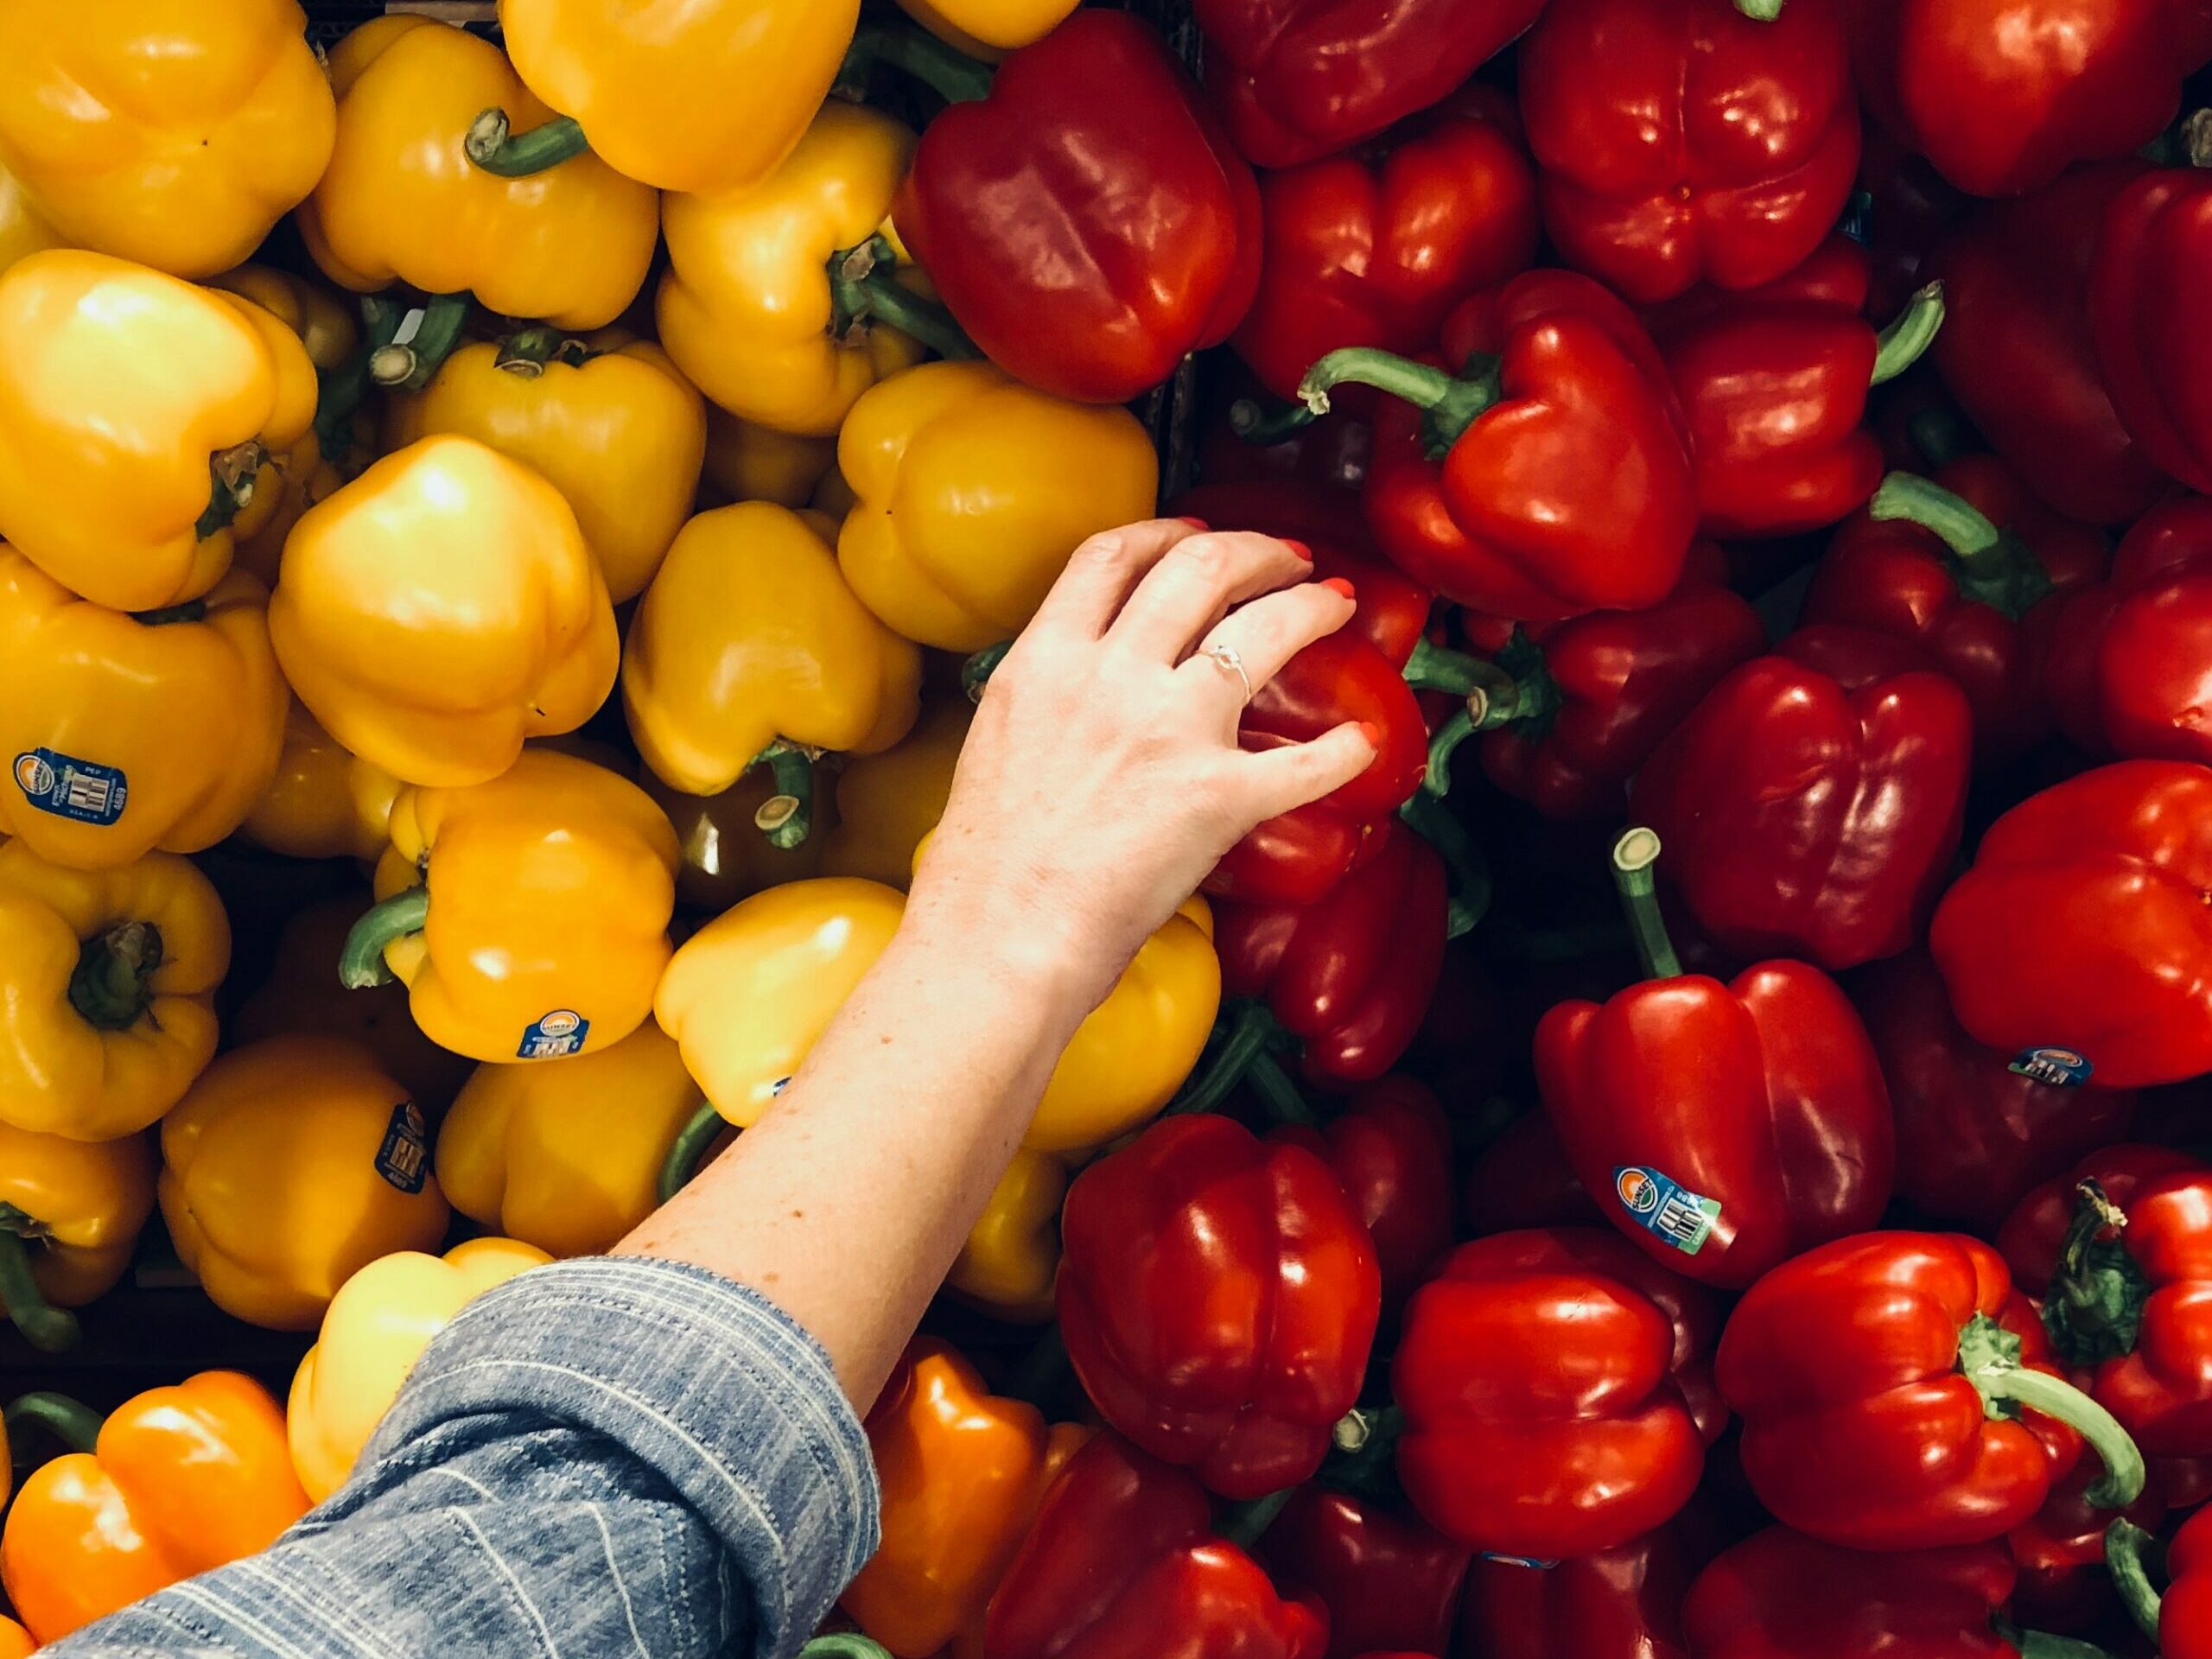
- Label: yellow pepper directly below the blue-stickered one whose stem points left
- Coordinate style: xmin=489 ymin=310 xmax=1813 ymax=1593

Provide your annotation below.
xmin=438 ymin=1020 xmax=702 ymax=1256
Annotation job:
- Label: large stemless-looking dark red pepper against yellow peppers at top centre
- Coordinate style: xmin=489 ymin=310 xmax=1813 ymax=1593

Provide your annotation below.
xmin=893 ymin=9 xmax=1261 ymax=403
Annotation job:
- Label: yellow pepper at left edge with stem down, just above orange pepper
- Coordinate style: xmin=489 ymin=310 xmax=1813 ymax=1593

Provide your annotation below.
xmin=0 ymin=1123 xmax=153 ymax=1353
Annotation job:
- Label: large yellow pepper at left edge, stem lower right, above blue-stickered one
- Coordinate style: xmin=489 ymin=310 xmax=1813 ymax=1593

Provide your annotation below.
xmin=0 ymin=248 xmax=316 ymax=611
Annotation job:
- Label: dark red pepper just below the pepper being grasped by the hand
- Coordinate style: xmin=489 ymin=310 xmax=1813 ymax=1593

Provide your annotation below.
xmin=1214 ymin=818 xmax=1446 ymax=1086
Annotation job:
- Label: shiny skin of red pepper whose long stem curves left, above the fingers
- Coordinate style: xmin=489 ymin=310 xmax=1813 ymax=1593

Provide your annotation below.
xmin=1365 ymin=270 xmax=1697 ymax=621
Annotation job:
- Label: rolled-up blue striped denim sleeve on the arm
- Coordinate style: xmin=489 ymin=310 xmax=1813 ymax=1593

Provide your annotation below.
xmin=51 ymin=1259 xmax=876 ymax=1659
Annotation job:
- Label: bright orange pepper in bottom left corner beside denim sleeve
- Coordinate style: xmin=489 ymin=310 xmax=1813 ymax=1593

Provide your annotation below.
xmin=0 ymin=1371 xmax=308 ymax=1642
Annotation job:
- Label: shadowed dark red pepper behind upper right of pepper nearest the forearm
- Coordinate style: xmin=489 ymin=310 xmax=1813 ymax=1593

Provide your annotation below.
xmin=1268 ymin=1077 xmax=1453 ymax=1318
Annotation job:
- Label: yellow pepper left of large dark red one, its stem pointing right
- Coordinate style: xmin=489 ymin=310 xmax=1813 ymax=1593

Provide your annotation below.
xmin=655 ymin=99 xmax=927 ymax=438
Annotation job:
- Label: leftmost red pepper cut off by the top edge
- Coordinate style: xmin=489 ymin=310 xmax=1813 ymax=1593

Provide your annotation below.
xmin=1190 ymin=0 xmax=1544 ymax=168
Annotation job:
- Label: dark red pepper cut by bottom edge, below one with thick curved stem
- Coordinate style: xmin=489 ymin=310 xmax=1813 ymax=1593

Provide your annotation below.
xmin=1681 ymin=1526 xmax=2018 ymax=1659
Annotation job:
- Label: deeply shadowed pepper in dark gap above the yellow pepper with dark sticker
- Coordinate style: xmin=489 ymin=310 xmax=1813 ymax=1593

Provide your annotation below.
xmin=226 ymin=896 xmax=474 ymax=1123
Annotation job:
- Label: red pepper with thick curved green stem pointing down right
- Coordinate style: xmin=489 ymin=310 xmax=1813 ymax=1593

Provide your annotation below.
xmin=1692 ymin=1232 xmax=2144 ymax=1557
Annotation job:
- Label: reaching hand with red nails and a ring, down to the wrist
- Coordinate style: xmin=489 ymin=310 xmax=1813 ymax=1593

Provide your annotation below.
xmin=909 ymin=518 xmax=1376 ymax=1013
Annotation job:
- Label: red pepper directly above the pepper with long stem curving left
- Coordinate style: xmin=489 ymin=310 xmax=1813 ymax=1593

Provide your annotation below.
xmin=1230 ymin=86 xmax=1537 ymax=409
